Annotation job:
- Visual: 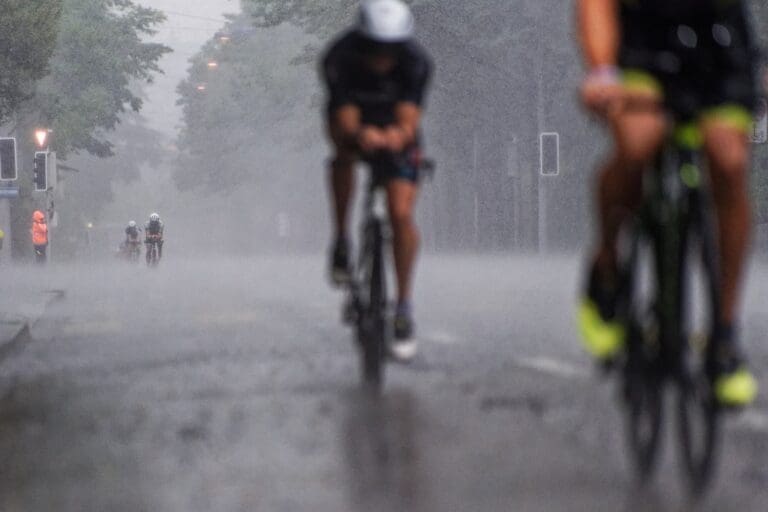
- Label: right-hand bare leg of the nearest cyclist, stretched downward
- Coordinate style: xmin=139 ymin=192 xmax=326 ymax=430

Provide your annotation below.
xmin=703 ymin=120 xmax=751 ymax=326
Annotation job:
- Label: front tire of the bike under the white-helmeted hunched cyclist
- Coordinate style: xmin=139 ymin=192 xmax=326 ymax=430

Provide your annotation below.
xmin=361 ymin=220 xmax=386 ymax=390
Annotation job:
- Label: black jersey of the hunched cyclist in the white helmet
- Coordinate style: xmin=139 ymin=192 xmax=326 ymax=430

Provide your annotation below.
xmin=322 ymin=31 xmax=432 ymax=126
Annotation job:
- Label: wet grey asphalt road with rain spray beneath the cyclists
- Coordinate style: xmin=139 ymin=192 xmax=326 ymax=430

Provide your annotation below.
xmin=0 ymin=257 xmax=768 ymax=512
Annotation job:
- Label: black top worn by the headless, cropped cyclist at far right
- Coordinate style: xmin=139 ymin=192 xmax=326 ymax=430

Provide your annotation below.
xmin=619 ymin=0 xmax=759 ymax=117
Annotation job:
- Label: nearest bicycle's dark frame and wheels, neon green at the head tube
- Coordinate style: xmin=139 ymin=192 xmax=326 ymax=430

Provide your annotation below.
xmin=620 ymin=128 xmax=720 ymax=492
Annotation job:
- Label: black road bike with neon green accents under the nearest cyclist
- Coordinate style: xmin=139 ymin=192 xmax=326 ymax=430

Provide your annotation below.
xmin=618 ymin=122 xmax=721 ymax=494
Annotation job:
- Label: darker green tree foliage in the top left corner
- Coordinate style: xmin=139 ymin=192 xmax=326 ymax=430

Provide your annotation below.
xmin=0 ymin=0 xmax=62 ymax=124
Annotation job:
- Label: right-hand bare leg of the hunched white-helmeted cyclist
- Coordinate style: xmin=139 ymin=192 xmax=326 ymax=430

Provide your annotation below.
xmin=387 ymin=179 xmax=419 ymax=303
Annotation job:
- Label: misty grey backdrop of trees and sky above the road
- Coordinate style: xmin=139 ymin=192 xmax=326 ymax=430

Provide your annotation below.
xmin=3 ymin=0 xmax=768 ymax=259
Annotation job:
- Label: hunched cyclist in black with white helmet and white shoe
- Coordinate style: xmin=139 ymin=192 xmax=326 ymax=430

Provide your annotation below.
xmin=322 ymin=0 xmax=432 ymax=360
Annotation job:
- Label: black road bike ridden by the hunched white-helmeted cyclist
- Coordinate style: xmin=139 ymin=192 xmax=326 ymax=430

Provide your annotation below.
xmin=343 ymin=154 xmax=435 ymax=390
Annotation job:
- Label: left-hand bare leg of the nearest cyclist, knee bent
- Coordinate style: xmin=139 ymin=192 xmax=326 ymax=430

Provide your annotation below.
xmin=597 ymin=112 xmax=666 ymax=272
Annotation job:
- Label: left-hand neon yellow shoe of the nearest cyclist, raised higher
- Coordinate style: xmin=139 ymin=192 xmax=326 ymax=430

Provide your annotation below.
xmin=577 ymin=298 xmax=626 ymax=361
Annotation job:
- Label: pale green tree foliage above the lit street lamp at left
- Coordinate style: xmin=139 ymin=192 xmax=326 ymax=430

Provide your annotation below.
xmin=35 ymin=0 xmax=170 ymax=157
